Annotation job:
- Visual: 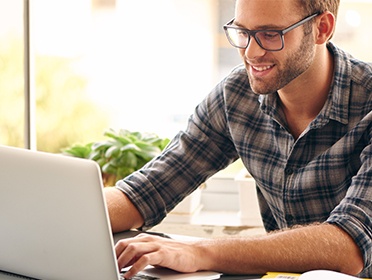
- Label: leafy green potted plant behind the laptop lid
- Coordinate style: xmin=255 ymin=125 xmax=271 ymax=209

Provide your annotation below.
xmin=62 ymin=129 xmax=170 ymax=186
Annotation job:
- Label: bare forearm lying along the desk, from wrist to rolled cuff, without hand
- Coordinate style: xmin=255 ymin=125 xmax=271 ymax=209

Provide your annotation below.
xmin=197 ymin=224 xmax=363 ymax=274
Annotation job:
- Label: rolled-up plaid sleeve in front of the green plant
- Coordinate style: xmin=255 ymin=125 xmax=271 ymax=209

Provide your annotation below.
xmin=116 ymin=77 xmax=238 ymax=228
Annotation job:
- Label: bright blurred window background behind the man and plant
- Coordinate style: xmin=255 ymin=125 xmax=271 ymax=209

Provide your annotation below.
xmin=0 ymin=0 xmax=372 ymax=152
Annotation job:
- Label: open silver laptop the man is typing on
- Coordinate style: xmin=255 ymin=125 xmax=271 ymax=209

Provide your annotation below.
xmin=0 ymin=146 xmax=220 ymax=280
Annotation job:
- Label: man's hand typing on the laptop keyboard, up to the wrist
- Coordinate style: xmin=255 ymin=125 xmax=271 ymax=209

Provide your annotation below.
xmin=115 ymin=234 xmax=200 ymax=279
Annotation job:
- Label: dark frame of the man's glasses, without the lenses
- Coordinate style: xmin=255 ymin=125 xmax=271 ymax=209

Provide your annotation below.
xmin=223 ymin=12 xmax=320 ymax=52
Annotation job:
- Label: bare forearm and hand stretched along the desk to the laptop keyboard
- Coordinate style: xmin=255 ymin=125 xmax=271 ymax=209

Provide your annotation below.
xmin=116 ymin=224 xmax=363 ymax=277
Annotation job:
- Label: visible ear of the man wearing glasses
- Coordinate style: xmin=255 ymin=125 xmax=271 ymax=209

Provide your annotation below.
xmin=315 ymin=11 xmax=336 ymax=44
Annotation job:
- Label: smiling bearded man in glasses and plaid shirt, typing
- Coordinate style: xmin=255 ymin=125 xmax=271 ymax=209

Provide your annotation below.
xmin=106 ymin=0 xmax=372 ymax=278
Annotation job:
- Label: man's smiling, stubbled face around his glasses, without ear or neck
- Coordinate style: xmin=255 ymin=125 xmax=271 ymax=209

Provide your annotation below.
xmin=235 ymin=0 xmax=315 ymax=94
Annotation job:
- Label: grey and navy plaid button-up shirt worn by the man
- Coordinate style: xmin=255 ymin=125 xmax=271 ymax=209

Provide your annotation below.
xmin=117 ymin=43 xmax=372 ymax=277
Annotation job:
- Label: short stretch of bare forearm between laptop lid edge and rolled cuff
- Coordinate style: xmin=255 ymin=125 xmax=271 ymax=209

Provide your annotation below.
xmin=104 ymin=187 xmax=144 ymax=232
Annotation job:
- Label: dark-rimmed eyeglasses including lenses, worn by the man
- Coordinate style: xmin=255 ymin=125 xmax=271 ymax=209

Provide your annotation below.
xmin=223 ymin=13 xmax=319 ymax=52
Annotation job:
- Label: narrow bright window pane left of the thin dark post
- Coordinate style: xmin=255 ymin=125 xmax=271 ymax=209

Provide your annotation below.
xmin=0 ymin=0 xmax=25 ymax=147
